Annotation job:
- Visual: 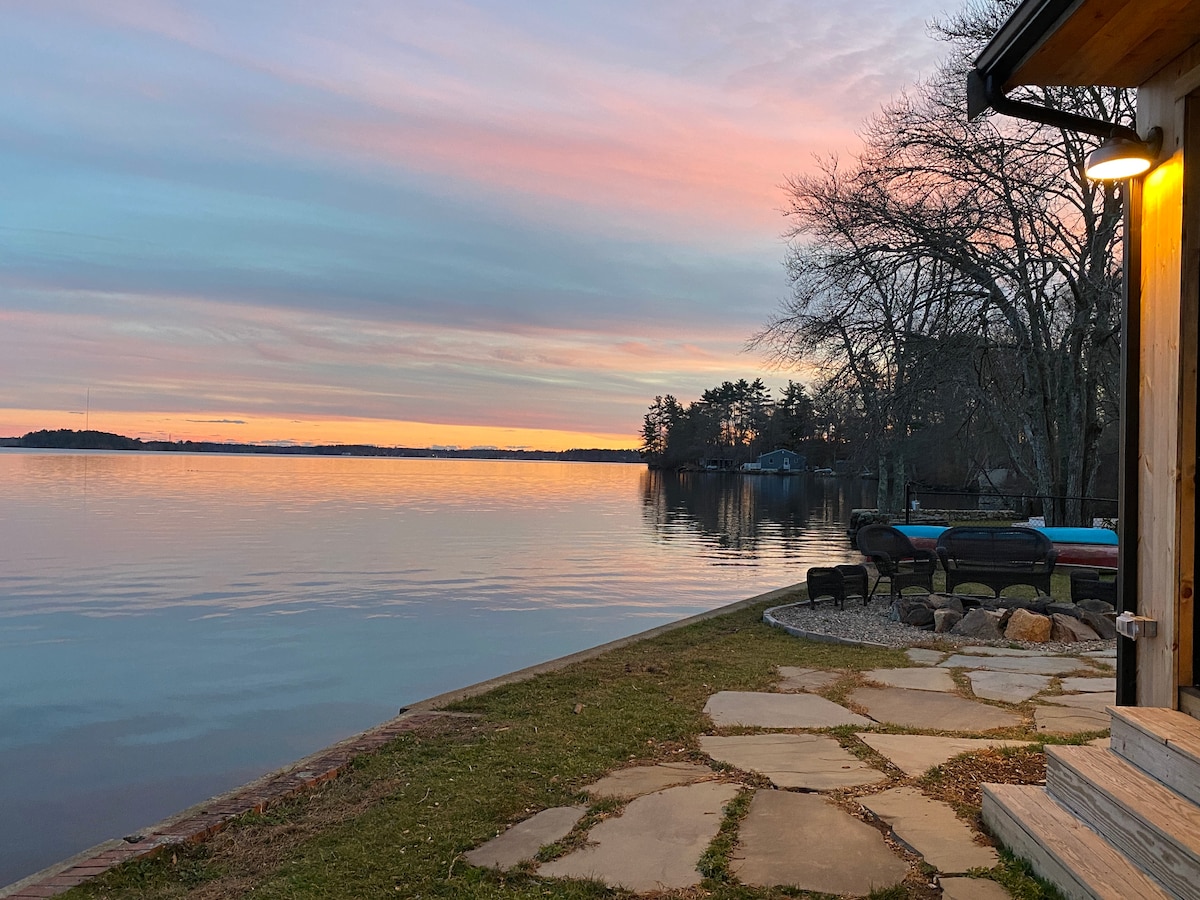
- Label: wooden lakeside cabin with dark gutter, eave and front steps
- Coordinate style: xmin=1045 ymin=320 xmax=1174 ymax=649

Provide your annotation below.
xmin=968 ymin=0 xmax=1200 ymax=898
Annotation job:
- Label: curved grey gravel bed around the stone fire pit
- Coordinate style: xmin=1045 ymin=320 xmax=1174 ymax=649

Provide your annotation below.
xmin=768 ymin=596 xmax=1117 ymax=654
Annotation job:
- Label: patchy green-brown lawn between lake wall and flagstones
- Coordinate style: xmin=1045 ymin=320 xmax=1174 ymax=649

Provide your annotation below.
xmin=65 ymin=605 xmax=1070 ymax=900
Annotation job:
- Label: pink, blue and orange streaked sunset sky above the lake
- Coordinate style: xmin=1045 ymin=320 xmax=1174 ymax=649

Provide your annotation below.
xmin=0 ymin=0 xmax=956 ymax=450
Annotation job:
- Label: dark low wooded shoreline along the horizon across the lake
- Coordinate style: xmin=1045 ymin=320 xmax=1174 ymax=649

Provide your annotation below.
xmin=0 ymin=428 xmax=643 ymax=463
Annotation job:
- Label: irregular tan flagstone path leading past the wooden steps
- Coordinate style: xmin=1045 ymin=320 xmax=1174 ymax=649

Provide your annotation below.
xmin=466 ymin=647 xmax=1115 ymax=900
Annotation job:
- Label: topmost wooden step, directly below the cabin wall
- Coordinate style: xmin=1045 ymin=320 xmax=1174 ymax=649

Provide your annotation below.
xmin=1110 ymin=707 xmax=1200 ymax=804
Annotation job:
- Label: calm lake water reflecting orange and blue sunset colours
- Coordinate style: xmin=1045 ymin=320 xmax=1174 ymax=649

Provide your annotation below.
xmin=0 ymin=450 xmax=874 ymax=886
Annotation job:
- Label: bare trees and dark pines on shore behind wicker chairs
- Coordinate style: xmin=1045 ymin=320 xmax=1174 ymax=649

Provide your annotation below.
xmin=643 ymin=0 xmax=1118 ymax=524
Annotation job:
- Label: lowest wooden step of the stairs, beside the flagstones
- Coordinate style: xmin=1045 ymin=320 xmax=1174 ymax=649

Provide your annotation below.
xmin=983 ymin=785 xmax=1171 ymax=900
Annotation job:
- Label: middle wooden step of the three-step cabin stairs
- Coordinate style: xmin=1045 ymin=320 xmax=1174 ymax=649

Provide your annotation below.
xmin=1046 ymin=746 xmax=1200 ymax=896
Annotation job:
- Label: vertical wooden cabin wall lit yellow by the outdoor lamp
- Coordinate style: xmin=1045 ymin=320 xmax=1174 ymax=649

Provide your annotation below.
xmin=1136 ymin=47 xmax=1200 ymax=708
